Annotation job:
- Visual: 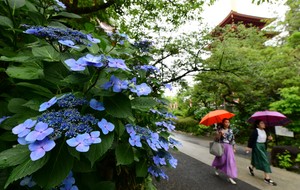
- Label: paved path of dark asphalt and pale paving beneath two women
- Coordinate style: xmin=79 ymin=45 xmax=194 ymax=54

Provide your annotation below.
xmin=155 ymin=133 xmax=300 ymax=190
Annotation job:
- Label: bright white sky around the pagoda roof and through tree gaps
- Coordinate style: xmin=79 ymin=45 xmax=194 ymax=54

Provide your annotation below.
xmin=165 ymin=0 xmax=287 ymax=96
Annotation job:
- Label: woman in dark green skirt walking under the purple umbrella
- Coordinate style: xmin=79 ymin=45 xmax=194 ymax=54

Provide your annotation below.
xmin=246 ymin=120 xmax=277 ymax=186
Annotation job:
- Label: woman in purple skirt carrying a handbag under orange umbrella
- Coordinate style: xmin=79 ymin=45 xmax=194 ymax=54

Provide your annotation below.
xmin=212 ymin=118 xmax=237 ymax=185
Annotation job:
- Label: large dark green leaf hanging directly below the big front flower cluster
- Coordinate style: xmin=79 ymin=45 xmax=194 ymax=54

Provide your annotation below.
xmin=33 ymin=142 xmax=74 ymax=189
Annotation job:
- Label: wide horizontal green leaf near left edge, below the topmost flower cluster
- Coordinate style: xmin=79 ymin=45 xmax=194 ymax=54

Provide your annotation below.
xmin=6 ymin=64 xmax=44 ymax=80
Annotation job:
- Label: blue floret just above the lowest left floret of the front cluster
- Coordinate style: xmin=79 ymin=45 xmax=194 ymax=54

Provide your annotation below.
xmin=25 ymin=122 xmax=54 ymax=142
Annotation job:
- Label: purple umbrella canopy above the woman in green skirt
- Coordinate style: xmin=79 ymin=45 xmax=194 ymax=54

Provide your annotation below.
xmin=247 ymin=110 xmax=291 ymax=127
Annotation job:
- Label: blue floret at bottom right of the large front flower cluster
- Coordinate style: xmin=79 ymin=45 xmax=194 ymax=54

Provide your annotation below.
xmin=67 ymin=133 xmax=92 ymax=152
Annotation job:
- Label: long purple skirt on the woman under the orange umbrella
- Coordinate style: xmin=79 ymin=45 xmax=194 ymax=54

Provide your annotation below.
xmin=212 ymin=143 xmax=237 ymax=178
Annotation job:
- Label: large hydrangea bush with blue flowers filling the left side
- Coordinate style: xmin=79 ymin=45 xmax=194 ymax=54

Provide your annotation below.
xmin=0 ymin=0 xmax=180 ymax=190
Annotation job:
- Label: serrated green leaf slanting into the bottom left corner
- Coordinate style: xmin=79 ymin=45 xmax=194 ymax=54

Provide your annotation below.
xmin=4 ymin=155 xmax=49 ymax=188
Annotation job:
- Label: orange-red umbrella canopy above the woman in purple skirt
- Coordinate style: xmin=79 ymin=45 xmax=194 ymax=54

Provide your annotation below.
xmin=200 ymin=110 xmax=235 ymax=126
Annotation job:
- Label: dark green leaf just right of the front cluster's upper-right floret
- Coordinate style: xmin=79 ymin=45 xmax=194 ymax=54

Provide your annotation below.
xmin=103 ymin=93 xmax=132 ymax=118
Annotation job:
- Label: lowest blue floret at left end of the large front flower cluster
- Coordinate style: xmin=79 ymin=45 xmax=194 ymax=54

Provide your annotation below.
xmin=28 ymin=137 xmax=55 ymax=161
